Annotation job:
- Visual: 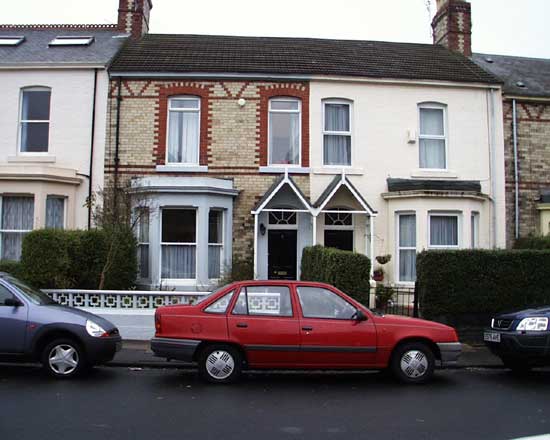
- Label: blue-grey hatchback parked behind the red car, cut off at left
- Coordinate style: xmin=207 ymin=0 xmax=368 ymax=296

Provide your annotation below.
xmin=0 ymin=272 xmax=121 ymax=378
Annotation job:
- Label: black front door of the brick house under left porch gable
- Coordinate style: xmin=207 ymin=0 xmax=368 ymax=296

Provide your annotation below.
xmin=267 ymin=229 xmax=297 ymax=280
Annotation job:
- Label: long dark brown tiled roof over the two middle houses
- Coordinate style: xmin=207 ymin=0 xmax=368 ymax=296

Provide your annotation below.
xmin=112 ymin=34 xmax=500 ymax=83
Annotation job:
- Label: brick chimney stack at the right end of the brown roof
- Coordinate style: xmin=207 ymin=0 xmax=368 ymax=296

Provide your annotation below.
xmin=432 ymin=0 xmax=472 ymax=57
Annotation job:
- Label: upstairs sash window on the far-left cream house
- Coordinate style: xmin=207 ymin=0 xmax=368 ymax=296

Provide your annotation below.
xmin=20 ymin=87 xmax=51 ymax=153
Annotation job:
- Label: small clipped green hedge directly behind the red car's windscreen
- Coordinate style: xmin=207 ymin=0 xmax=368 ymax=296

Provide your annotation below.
xmin=301 ymin=245 xmax=371 ymax=304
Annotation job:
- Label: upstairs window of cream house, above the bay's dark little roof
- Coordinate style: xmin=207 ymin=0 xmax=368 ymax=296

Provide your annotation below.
xmin=419 ymin=105 xmax=447 ymax=169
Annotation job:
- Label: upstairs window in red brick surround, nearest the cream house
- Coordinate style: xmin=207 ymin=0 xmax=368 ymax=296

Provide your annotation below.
xmin=268 ymin=98 xmax=302 ymax=165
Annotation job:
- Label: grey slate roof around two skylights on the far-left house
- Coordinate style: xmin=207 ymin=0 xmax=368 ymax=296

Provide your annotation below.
xmin=0 ymin=25 xmax=126 ymax=67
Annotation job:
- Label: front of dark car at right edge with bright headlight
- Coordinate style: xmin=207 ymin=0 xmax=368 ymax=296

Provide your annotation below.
xmin=483 ymin=306 xmax=550 ymax=371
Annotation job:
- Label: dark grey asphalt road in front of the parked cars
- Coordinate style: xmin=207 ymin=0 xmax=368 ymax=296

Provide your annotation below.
xmin=0 ymin=366 xmax=550 ymax=440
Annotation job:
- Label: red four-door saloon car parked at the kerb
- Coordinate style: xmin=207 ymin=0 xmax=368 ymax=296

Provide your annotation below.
xmin=151 ymin=281 xmax=461 ymax=383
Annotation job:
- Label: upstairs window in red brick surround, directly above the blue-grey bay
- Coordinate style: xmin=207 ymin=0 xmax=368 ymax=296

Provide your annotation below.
xmin=167 ymin=96 xmax=201 ymax=165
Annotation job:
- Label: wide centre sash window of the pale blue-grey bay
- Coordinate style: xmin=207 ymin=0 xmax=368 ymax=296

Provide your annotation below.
xmin=161 ymin=208 xmax=197 ymax=279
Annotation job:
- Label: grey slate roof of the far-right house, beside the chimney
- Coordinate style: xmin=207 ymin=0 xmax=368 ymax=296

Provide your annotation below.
xmin=472 ymin=53 xmax=550 ymax=98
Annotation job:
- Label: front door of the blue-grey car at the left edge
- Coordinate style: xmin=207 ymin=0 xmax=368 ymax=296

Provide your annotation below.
xmin=0 ymin=284 xmax=29 ymax=354
